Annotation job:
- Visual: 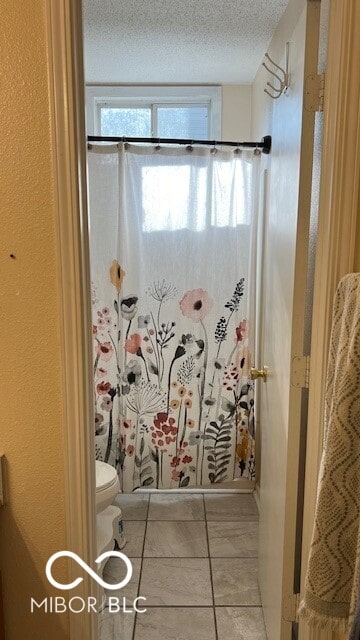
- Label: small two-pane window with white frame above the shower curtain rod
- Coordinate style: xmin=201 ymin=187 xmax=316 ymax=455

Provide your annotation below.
xmin=86 ymin=86 xmax=221 ymax=140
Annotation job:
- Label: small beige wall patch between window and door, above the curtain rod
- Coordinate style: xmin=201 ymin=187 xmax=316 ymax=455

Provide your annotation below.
xmin=221 ymin=84 xmax=252 ymax=142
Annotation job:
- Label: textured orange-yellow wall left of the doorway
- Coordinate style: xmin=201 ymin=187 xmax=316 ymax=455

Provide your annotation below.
xmin=0 ymin=0 xmax=68 ymax=640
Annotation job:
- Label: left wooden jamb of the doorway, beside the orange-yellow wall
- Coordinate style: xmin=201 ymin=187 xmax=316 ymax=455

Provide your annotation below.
xmin=46 ymin=0 xmax=98 ymax=640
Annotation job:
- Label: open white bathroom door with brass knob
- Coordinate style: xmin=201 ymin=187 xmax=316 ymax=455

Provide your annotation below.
xmin=251 ymin=0 xmax=316 ymax=640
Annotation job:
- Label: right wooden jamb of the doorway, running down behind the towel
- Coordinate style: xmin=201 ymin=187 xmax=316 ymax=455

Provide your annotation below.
xmin=300 ymin=0 xmax=360 ymax=640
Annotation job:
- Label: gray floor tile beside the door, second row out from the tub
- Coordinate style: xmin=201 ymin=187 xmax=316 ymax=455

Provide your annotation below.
xmin=207 ymin=521 xmax=259 ymax=558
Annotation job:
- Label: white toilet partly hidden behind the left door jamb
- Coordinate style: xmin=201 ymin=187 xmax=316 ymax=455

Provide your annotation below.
xmin=95 ymin=460 xmax=126 ymax=608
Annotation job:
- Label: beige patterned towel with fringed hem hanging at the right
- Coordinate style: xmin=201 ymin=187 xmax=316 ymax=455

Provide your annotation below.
xmin=299 ymin=273 xmax=360 ymax=640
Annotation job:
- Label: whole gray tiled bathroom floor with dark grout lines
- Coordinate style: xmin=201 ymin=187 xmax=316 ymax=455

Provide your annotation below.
xmin=100 ymin=493 xmax=266 ymax=640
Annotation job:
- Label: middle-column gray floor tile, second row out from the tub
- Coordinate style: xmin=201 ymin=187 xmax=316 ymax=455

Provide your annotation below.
xmin=144 ymin=521 xmax=208 ymax=558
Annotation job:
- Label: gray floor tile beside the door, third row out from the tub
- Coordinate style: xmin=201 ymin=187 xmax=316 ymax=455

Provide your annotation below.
xmin=211 ymin=558 xmax=261 ymax=606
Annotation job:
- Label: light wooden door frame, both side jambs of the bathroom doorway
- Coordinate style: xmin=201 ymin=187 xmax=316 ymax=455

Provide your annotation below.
xmin=46 ymin=0 xmax=360 ymax=640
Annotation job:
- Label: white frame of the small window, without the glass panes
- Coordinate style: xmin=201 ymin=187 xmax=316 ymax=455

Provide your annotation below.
xmin=86 ymin=85 xmax=221 ymax=140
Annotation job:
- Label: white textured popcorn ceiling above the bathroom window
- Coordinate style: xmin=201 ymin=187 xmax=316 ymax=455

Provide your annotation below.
xmin=83 ymin=0 xmax=288 ymax=84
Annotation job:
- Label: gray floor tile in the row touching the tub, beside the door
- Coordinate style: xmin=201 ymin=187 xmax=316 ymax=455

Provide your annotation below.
xmin=205 ymin=493 xmax=259 ymax=522
